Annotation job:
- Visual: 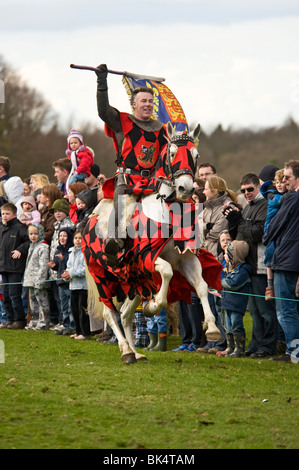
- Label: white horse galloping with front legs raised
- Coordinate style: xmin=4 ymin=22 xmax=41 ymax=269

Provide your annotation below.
xmin=85 ymin=123 xmax=221 ymax=364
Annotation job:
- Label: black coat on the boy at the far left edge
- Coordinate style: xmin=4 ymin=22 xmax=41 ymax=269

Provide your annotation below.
xmin=0 ymin=218 xmax=30 ymax=273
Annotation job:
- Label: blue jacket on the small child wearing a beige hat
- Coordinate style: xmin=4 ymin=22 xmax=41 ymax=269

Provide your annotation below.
xmin=221 ymin=263 xmax=252 ymax=314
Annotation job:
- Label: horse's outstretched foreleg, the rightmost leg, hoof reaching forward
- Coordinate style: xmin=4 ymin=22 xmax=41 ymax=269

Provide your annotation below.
xmin=180 ymin=251 xmax=222 ymax=341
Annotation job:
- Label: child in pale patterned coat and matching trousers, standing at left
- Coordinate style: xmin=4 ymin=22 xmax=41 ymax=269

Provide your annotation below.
xmin=23 ymin=224 xmax=50 ymax=330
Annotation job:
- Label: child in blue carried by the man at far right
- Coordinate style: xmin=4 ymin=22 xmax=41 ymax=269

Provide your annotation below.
xmin=260 ymin=169 xmax=286 ymax=300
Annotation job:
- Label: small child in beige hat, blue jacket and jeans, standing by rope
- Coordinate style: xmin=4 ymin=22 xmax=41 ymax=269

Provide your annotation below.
xmin=218 ymin=240 xmax=251 ymax=357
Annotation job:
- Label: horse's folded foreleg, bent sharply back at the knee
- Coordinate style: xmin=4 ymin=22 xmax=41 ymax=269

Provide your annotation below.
xmin=143 ymin=256 xmax=173 ymax=317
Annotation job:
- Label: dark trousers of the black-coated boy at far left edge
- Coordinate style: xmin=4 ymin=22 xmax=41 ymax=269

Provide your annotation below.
xmin=2 ymin=272 xmax=26 ymax=325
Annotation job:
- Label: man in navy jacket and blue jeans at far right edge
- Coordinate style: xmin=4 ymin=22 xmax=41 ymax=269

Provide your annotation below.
xmin=263 ymin=160 xmax=299 ymax=363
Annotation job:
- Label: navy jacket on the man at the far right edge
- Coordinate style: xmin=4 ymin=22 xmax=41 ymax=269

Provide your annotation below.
xmin=263 ymin=191 xmax=299 ymax=273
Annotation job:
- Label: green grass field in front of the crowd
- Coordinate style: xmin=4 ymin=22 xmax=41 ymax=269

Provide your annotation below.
xmin=0 ymin=314 xmax=299 ymax=449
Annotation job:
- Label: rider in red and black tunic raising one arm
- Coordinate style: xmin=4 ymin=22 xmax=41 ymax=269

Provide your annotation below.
xmin=96 ymin=65 xmax=167 ymax=264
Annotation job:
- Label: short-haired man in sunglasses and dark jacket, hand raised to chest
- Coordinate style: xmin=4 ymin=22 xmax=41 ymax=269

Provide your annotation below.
xmin=223 ymin=173 xmax=277 ymax=359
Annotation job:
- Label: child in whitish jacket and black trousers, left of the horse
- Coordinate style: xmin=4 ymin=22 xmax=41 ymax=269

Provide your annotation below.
xmin=61 ymin=230 xmax=90 ymax=340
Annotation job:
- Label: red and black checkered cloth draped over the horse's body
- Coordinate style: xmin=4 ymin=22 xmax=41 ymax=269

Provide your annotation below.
xmin=82 ymin=200 xmax=222 ymax=311
